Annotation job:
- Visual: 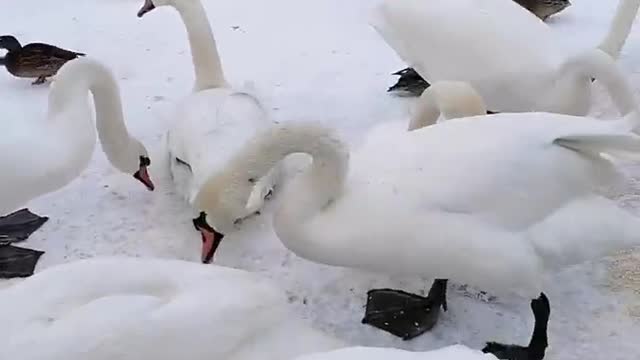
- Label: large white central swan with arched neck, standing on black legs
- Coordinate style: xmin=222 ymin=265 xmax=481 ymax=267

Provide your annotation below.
xmin=192 ymin=53 xmax=640 ymax=338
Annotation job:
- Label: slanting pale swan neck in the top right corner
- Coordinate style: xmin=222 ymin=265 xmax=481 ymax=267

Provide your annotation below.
xmin=598 ymin=0 xmax=640 ymax=59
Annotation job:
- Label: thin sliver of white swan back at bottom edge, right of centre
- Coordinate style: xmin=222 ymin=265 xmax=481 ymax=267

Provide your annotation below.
xmin=296 ymin=345 xmax=497 ymax=360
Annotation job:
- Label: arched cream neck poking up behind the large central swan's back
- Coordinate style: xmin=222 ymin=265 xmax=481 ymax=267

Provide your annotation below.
xmin=409 ymin=81 xmax=486 ymax=131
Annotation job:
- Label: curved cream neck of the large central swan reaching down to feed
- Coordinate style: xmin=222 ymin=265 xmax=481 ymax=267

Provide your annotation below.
xmin=194 ymin=123 xmax=349 ymax=241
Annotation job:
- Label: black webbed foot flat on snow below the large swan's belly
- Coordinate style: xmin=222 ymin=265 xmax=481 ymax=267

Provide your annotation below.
xmin=362 ymin=279 xmax=447 ymax=340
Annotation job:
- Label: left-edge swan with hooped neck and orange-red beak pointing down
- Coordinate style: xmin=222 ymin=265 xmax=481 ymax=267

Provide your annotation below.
xmin=0 ymin=58 xmax=153 ymax=214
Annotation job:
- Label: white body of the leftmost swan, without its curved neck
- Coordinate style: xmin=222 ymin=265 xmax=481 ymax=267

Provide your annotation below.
xmin=0 ymin=106 xmax=96 ymax=215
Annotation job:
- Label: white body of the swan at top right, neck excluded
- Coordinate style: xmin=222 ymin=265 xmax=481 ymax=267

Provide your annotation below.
xmin=371 ymin=0 xmax=566 ymax=111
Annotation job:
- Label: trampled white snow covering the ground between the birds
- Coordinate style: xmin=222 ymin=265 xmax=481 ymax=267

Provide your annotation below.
xmin=0 ymin=0 xmax=640 ymax=360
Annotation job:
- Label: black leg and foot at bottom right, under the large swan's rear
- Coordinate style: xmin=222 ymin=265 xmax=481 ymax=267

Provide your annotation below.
xmin=482 ymin=293 xmax=551 ymax=360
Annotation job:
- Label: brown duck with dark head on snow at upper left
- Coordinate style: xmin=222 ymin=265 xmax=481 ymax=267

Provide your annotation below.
xmin=0 ymin=35 xmax=85 ymax=84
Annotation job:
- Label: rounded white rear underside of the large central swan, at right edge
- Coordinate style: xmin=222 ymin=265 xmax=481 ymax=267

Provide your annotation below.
xmin=529 ymin=197 xmax=640 ymax=271
